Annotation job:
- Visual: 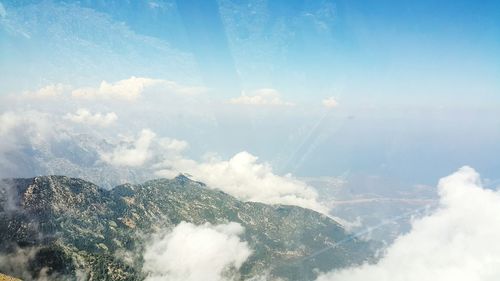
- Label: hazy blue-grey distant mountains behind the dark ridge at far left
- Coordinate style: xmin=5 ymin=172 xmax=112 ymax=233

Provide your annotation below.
xmin=0 ymin=130 xmax=154 ymax=189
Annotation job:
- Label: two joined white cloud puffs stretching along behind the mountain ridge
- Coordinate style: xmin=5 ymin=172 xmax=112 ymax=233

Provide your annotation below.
xmin=100 ymin=129 xmax=329 ymax=214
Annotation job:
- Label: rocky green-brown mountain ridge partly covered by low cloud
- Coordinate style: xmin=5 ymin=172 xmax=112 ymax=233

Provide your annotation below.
xmin=0 ymin=175 xmax=373 ymax=280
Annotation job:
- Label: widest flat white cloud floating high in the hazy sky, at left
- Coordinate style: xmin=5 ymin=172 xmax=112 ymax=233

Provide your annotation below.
xmin=71 ymin=76 xmax=206 ymax=101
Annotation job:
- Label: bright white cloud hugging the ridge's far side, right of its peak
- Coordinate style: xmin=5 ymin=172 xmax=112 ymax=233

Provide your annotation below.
xmin=156 ymin=151 xmax=328 ymax=214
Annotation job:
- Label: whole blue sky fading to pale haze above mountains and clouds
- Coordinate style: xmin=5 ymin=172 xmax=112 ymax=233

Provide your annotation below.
xmin=0 ymin=0 xmax=500 ymax=185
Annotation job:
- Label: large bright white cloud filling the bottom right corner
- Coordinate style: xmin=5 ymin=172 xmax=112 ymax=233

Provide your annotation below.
xmin=317 ymin=167 xmax=500 ymax=281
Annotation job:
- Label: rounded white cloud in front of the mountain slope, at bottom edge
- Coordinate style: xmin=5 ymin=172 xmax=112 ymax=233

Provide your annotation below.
xmin=143 ymin=222 xmax=252 ymax=281
